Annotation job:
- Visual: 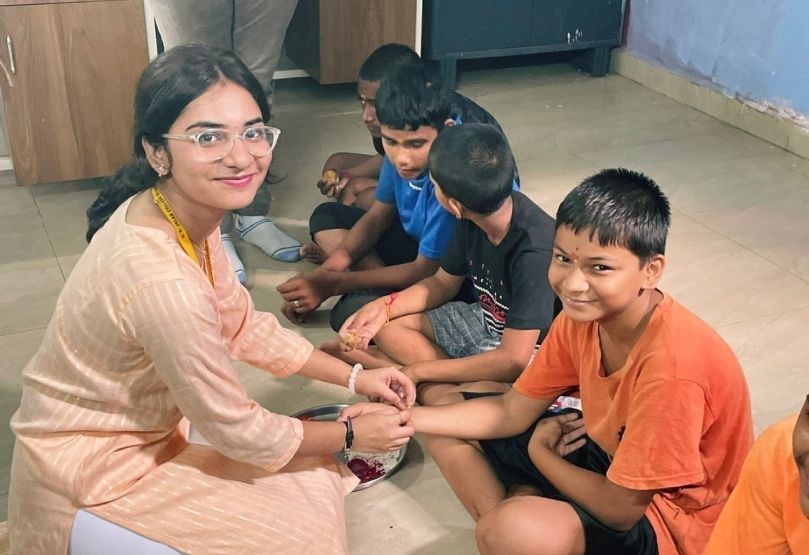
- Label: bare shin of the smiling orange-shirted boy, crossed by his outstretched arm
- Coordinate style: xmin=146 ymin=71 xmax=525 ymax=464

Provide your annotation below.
xmin=427 ymin=384 xmax=506 ymax=520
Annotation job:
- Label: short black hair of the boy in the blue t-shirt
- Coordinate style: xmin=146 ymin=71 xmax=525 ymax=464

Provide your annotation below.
xmin=376 ymin=64 xmax=452 ymax=131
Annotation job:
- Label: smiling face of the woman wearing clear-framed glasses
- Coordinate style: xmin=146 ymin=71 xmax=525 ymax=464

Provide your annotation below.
xmin=160 ymin=81 xmax=272 ymax=210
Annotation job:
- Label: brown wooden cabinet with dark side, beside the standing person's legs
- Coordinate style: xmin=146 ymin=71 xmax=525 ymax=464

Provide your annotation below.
xmin=285 ymin=0 xmax=421 ymax=85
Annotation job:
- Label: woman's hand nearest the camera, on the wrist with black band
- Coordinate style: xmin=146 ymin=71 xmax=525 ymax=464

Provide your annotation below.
xmin=338 ymin=403 xmax=415 ymax=452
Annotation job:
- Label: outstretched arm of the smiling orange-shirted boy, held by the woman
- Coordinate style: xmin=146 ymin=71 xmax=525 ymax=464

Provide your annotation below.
xmin=411 ymin=389 xmax=556 ymax=439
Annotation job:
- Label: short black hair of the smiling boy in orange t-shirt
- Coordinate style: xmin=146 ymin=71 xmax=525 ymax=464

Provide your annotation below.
xmin=556 ymin=168 xmax=671 ymax=266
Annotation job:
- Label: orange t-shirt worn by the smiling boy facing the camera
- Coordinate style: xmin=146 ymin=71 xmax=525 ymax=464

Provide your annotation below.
xmin=514 ymin=295 xmax=753 ymax=555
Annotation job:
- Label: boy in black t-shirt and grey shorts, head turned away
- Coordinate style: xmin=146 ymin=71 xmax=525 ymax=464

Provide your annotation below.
xmin=340 ymin=123 xmax=555 ymax=404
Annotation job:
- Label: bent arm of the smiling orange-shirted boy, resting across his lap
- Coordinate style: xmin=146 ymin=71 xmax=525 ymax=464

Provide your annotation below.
xmin=528 ymin=414 xmax=655 ymax=531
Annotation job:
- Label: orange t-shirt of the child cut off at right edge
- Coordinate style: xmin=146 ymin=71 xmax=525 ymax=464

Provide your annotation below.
xmin=705 ymin=415 xmax=809 ymax=555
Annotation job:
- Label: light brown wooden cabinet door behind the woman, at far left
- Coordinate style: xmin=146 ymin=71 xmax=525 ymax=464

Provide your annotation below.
xmin=0 ymin=0 xmax=148 ymax=185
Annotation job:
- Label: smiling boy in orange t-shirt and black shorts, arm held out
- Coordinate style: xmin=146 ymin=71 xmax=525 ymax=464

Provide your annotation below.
xmin=353 ymin=169 xmax=753 ymax=555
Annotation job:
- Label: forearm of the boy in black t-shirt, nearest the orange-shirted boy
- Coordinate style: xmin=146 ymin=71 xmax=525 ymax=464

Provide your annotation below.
xmin=397 ymin=326 xmax=540 ymax=383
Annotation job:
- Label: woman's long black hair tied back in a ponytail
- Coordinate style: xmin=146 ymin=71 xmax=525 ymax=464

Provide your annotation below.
xmin=86 ymin=44 xmax=270 ymax=242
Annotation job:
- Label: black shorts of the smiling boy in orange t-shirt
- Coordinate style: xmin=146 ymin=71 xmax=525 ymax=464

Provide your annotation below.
xmin=463 ymin=392 xmax=658 ymax=555
